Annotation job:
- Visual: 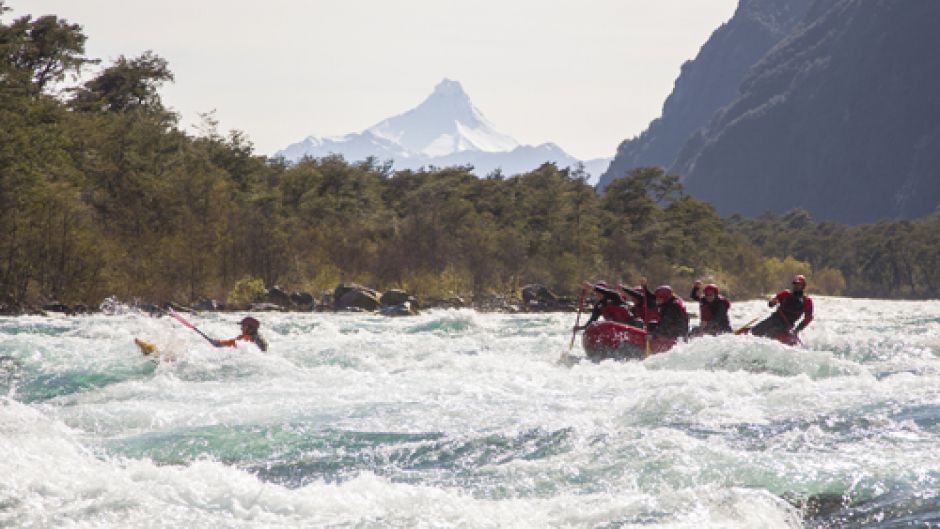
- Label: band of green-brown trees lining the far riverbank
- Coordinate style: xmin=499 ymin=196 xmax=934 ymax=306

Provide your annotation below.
xmin=0 ymin=3 xmax=940 ymax=307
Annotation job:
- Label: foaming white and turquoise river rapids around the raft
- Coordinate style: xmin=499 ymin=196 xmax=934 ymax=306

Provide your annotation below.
xmin=0 ymin=298 xmax=940 ymax=528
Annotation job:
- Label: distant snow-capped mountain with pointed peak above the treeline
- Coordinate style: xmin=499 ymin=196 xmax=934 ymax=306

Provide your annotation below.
xmin=276 ymin=79 xmax=610 ymax=181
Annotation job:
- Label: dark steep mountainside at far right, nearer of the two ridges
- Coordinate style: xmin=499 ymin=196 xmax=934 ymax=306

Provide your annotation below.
xmin=672 ymin=0 xmax=940 ymax=223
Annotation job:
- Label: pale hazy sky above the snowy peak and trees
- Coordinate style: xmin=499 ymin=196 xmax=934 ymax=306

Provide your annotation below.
xmin=11 ymin=0 xmax=737 ymax=159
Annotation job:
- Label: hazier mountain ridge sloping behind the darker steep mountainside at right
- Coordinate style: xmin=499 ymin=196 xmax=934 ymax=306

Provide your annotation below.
xmin=599 ymin=0 xmax=811 ymax=189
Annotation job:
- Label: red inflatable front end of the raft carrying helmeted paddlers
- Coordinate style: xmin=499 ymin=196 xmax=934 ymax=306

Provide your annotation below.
xmin=581 ymin=321 xmax=676 ymax=360
